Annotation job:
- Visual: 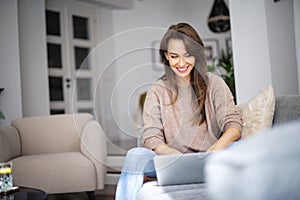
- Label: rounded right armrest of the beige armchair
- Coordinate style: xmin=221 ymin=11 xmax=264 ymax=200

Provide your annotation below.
xmin=80 ymin=121 xmax=107 ymax=190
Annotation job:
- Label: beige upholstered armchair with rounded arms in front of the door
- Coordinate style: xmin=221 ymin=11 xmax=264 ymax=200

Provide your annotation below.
xmin=0 ymin=114 xmax=106 ymax=198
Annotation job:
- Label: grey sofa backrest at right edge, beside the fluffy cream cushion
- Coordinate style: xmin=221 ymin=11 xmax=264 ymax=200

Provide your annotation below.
xmin=273 ymin=96 xmax=300 ymax=125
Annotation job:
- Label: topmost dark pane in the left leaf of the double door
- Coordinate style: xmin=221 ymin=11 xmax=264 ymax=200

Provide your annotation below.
xmin=46 ymin=10 xmax=60 ymax=36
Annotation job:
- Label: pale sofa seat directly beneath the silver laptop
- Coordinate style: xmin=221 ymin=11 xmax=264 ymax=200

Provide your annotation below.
xmin=136 ymin=181 xmax=209 ymax=200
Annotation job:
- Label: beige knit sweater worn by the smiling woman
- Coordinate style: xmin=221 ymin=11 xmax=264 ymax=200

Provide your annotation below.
xmin=143 ymin=73 xmax=242 ymax=153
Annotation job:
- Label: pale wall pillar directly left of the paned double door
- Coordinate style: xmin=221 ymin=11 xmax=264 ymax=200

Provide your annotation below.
xmin=18 ymin=0 xmax=50 ymax=117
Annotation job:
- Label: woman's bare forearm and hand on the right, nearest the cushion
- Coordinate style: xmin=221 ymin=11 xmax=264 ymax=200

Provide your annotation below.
xmin=207 ymin=128 xmax=241 ymax=152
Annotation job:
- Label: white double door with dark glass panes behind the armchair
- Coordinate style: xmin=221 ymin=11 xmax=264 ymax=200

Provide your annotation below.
xmin=46 ymin=1 xmax=94 ymax=114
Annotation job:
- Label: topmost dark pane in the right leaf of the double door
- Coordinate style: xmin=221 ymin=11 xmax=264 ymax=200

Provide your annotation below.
xmin=73 ymin=15 xmax=89 ymax=40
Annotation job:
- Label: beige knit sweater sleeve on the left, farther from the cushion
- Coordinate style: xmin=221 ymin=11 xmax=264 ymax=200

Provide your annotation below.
xmin=143 ymin=81 xmax=165 ymax=150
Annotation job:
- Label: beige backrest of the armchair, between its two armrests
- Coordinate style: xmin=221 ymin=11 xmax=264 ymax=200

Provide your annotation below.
xmin=11 ymin=114 xmax=93 ymax=155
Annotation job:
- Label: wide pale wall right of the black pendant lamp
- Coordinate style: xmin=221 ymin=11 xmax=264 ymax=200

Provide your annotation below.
xmin=230 ymin=0 xmax=298 ymax=103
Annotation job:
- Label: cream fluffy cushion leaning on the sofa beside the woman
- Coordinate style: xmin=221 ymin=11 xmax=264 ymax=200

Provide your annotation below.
xmin=238 ymin=86 xmax=275 ymax=138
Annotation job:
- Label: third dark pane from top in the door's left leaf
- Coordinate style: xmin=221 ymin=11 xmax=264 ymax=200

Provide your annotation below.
xmin=49 ymin=76 xmax=64 ymax=101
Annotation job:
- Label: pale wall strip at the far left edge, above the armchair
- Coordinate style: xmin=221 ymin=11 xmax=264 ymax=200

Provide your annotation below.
xmin=0 ymin=0 xmax=22 ymax=126
